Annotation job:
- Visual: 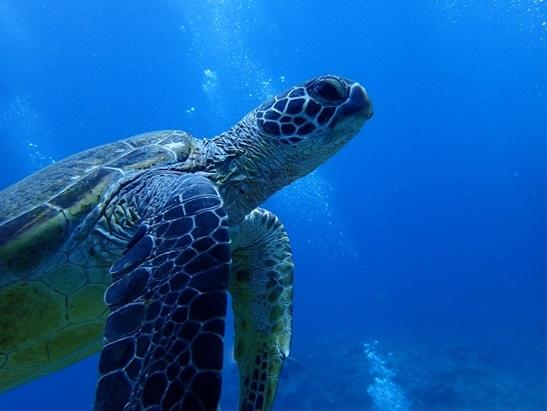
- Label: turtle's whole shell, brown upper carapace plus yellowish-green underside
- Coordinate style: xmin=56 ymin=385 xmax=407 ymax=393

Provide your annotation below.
xmin=0 ymin=131 xmax=196 ymax=392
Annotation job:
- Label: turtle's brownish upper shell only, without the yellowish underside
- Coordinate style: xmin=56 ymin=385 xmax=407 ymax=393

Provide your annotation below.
xmin=0 ymin=130 xmax=195 ymax=278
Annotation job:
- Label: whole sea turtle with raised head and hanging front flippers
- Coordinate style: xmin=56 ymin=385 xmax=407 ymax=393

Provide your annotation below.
xmin=0 ymin=75 xmax=372 ymax=411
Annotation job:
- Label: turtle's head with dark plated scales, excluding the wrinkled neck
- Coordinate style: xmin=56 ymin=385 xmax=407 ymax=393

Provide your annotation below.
xmin=254 ymin=75 xmax=372 ymax=182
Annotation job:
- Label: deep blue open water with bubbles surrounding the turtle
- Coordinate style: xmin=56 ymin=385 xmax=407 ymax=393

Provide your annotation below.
xmin=0 ymin=0 xmax=547 ymax=411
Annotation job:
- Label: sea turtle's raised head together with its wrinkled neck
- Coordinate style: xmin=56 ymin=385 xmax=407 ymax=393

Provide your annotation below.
xmin=209 ymin=75 xmax=372 ymax=222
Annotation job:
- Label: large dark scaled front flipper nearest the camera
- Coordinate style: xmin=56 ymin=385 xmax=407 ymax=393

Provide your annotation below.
xmin=95 ymin=172 xmax=230 ymax=411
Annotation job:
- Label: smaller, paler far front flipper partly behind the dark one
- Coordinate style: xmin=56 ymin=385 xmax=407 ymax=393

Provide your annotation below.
xmin=229 ymin=209 xmax=294 ymax=411
